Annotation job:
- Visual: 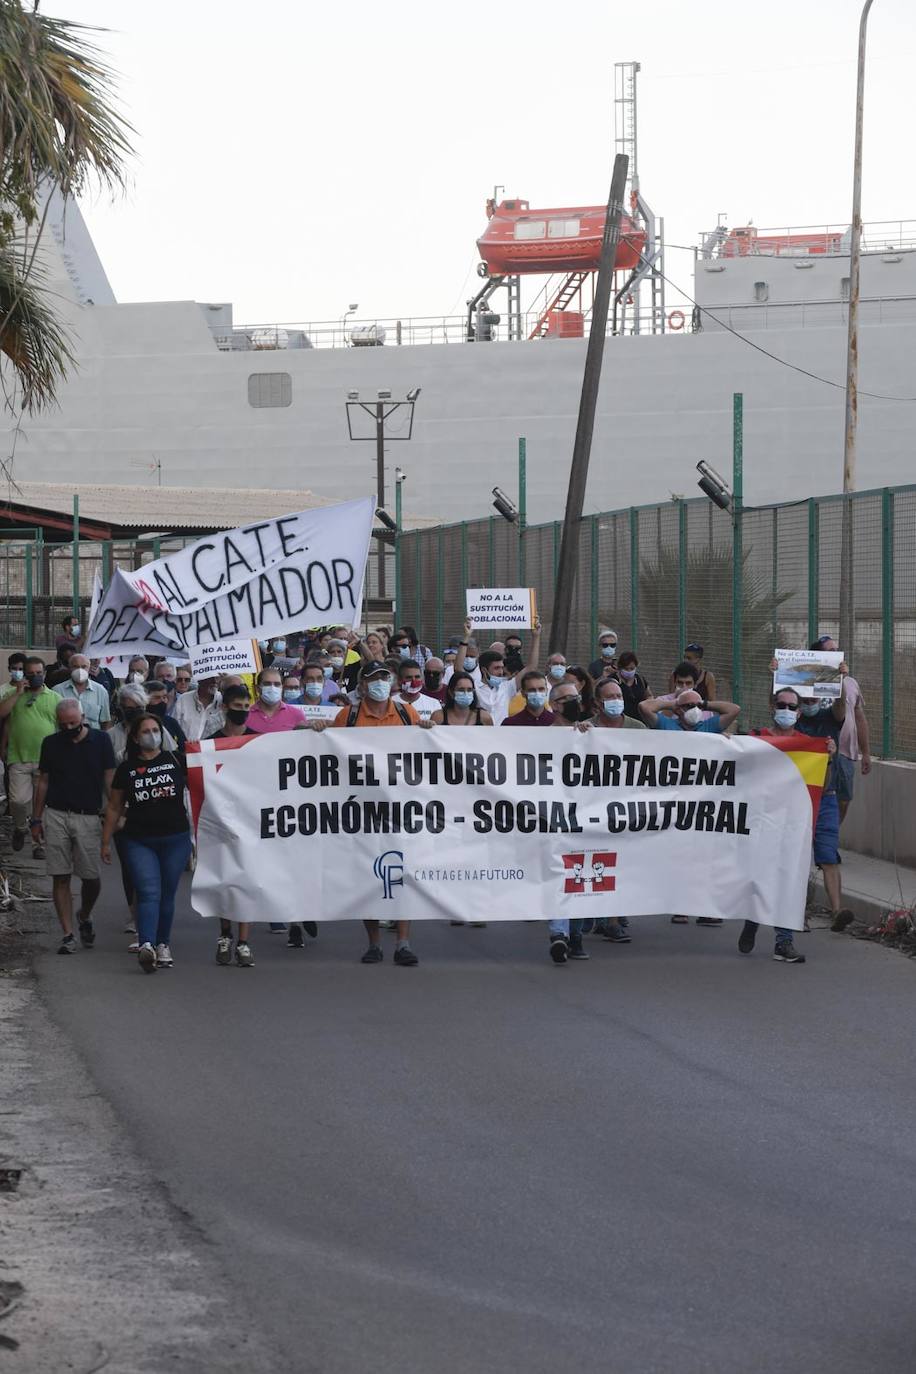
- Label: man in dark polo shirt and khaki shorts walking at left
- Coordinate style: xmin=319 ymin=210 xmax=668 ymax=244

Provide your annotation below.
xmin=32 ymin=697 xmax=114 ymax=954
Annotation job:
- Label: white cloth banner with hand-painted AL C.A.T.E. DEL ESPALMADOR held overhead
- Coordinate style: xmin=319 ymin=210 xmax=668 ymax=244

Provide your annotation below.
xmin=87 ymin=497 xmax=375 ymax=657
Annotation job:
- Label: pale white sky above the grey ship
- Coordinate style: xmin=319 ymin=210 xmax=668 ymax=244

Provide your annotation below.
xmin=55 ymin=0 xmax=916 ymax=324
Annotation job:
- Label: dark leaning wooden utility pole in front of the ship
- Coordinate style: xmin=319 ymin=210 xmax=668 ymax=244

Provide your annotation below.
xmin=549 ymin=153 xmax=629 ymax=654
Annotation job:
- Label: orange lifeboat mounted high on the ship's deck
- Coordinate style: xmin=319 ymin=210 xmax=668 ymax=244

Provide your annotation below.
xmin=477 ymin=201 xmax=645 ymax=276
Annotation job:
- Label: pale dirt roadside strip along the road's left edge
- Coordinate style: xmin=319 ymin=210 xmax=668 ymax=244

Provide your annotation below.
xmin=0 ymin=862 xmax=287 ymax=1374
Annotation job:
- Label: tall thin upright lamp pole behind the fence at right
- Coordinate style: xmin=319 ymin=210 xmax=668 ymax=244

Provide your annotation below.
xmin=839 ymin=0 xmax=872 ymax=654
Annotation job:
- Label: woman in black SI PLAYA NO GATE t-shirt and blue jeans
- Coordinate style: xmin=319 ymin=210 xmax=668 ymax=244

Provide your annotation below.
xmin=102 ymin=712 xmax=191 ymax=973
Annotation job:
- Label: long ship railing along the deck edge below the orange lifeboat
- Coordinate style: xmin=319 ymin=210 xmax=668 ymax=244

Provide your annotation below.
xmin=211 ymin=309 xmax=689 ymax=353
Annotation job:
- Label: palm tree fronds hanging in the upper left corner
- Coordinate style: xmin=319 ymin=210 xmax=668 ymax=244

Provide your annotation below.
xmin=0 ymin=0 xmax=133 ymax=411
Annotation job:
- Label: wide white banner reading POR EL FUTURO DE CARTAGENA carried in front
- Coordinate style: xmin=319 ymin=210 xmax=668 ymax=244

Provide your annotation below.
xmin=188 ymin=727 xmax=827 ymax=930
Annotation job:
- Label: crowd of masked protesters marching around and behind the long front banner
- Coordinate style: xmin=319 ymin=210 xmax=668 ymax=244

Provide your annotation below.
xmin=0 ymin=617 xmax=871 ymax=973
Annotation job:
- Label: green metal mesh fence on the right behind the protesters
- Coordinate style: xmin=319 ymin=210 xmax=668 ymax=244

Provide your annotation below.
xmin=397 ymin=486 xmax=916 ymax=758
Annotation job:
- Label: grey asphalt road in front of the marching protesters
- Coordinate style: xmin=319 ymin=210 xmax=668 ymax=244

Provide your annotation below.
xmin=32 ymin=874 xmax=916 ymax=1374
